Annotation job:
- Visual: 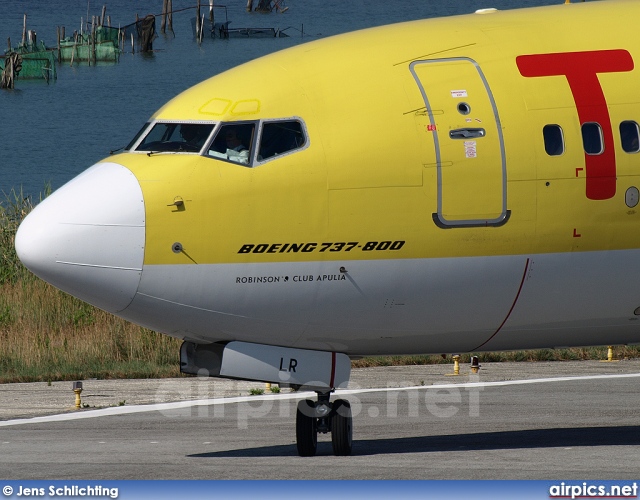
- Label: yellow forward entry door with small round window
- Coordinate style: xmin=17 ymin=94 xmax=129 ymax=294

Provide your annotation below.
xmin=409 ymin=57 xmax=509 ymax=228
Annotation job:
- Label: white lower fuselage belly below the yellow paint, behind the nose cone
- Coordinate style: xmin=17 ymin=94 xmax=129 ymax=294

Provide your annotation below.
xmin=119 ymin=250 xmax=640 ymax=355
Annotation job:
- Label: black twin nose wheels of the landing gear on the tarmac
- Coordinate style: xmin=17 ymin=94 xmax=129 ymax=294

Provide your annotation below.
xmin=296 ymin=392 xmax=353 ymax=457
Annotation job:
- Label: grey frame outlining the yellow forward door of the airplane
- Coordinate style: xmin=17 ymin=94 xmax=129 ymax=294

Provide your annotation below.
xmin=409 ymin=57 xmax=511 ymax=229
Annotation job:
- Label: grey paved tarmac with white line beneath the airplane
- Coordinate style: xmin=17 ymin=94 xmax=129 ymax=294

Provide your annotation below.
xmin=0 ymin=360 xmax=640 ymax=480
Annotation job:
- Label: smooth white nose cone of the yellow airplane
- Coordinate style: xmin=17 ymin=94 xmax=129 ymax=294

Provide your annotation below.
xmin=15 ymin=162 xmax=145 ymax=312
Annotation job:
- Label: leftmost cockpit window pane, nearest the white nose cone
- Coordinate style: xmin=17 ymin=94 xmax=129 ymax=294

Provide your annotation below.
xmin=136 ymin=122 xmax=215 ymax=153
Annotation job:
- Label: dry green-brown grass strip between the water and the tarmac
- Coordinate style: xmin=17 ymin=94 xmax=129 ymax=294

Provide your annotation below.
xmin=0 ymin=191 xmax=640 ymax=382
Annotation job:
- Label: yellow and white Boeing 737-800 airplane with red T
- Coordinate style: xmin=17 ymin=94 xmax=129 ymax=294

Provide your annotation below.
xmin=16 ymin=0 xmax=640 ymax=455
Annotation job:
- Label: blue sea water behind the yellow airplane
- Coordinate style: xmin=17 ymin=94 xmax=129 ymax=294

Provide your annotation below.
xmin=0 ymin=0 xmax=560 ymax=199
